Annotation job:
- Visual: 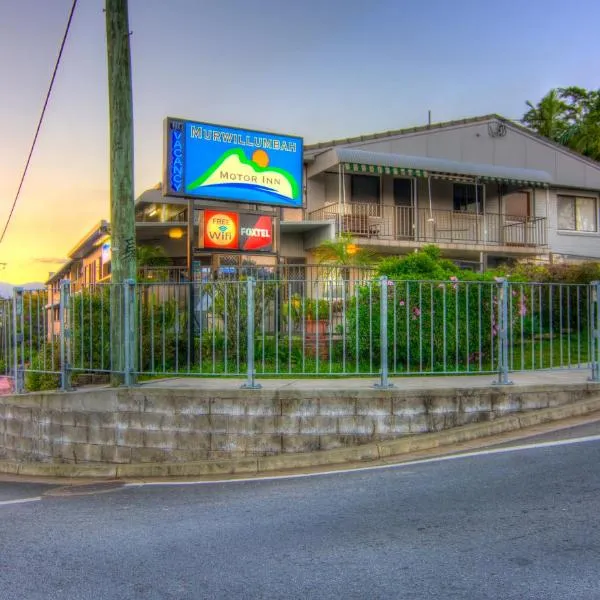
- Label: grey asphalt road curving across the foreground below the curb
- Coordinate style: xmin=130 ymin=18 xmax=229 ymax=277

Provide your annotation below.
xmin=0 ymin=426 xmax=600 ymax=600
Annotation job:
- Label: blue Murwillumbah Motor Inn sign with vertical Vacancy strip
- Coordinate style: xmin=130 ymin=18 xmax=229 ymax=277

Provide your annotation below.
xmin=163 ymin=118 xmax=303 ymax=208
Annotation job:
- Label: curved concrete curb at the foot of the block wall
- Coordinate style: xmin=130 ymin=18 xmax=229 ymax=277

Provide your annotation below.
xmin=0 ymin=396 xmax=600 ymax=479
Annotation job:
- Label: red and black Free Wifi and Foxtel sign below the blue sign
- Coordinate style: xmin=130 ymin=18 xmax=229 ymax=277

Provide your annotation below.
xmin=200 ymin=210 xmax=273 ymax=252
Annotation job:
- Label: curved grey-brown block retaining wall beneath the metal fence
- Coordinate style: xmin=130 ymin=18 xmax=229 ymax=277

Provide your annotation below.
xmin=0 ymin=382 xmax=598 ymax=463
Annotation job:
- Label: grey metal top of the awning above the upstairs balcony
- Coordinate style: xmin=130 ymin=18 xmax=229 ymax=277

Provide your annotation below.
xmin=332 ymin=147 xmax=552 ymax=185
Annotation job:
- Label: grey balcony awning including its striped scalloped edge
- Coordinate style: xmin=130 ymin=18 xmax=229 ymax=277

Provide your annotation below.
xmin=333 ymin=148 xmax=552 ymax=187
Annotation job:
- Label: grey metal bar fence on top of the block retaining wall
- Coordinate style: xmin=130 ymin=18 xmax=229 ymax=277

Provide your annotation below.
xmin=0 ymin=272 xmax=600 ymax=392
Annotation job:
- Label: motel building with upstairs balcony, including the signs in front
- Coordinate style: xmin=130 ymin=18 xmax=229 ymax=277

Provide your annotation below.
xmin=47 ymin=115 xmax=600 ymax=330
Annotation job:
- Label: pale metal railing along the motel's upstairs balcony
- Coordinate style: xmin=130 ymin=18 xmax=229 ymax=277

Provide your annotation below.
xmin=309 ymin=203 xmax=547 ymax=247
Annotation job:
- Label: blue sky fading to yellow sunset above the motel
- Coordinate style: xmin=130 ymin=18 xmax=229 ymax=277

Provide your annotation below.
xmin=0 ymin=0 xmax=600 ymax=284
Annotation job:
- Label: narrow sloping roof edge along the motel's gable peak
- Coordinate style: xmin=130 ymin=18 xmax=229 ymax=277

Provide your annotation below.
xmin=304 ymin=113 xmax=600 ymax=169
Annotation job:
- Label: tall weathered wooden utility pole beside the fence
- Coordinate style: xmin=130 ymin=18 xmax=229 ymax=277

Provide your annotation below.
xmin=105 ymin=0 xmax=137 ymax=385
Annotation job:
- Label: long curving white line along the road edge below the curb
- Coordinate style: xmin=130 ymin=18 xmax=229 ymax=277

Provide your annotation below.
xmin=124 ymin=435 xmax=600 ymax=487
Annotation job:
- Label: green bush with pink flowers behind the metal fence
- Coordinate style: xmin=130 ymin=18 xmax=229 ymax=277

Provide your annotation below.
xmin=338 ymin=281 xmax=498 ymax=371
